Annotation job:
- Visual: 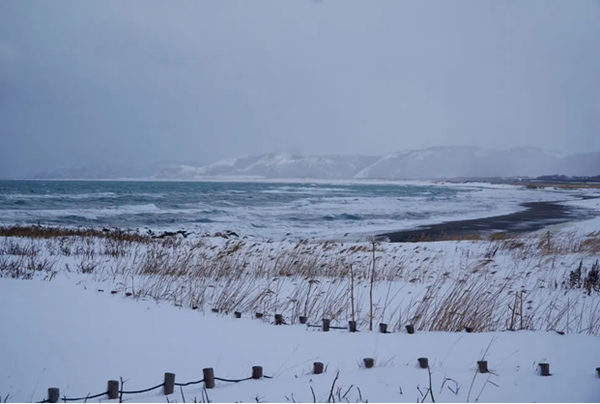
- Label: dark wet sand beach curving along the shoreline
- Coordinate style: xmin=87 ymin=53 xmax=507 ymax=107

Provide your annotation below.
xmin=379 ymin=202 xmax=592 ymax=243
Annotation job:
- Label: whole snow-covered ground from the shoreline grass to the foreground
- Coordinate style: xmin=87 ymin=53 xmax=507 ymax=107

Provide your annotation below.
xmin=0 ymin=193 xmax=600 ymax=402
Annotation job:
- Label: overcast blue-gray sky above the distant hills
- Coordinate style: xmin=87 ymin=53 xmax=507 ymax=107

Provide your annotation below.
xmin=0 ymin=0 xmax=600 ymax=177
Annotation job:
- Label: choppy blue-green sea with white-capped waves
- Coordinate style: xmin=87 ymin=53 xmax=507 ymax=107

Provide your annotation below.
xmin=0 ymin=180 xmax=568 ymax=240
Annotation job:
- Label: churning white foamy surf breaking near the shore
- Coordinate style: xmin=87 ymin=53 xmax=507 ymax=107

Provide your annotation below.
xmin=0 ymin=184 xmax=584 ymax=238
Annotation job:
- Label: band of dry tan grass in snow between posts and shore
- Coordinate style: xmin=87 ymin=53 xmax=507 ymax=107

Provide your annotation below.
xmin=0 ymin=224 xmax=600 ymax=335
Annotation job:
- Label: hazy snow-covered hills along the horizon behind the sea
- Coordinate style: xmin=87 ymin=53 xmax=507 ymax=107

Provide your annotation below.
xmin=30 ymin=146 xmax=600 ymax=180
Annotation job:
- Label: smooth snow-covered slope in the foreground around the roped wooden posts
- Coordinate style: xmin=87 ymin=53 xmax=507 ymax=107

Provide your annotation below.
xmin=0 ymin=280 xmax=600 ymax=402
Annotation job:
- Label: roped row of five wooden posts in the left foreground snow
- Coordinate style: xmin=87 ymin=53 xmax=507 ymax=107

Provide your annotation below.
xmin=37 ymin=366 xmax=272 ymax=403
